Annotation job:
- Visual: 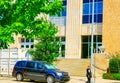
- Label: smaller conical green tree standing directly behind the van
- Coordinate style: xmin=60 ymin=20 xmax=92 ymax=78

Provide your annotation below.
xmin=28 ymin=20 xmax=61 ymax=63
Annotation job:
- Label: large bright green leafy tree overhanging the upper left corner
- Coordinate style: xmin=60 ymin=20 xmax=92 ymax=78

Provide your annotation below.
xmin=0 ymin=0 xmax=63 ymax=48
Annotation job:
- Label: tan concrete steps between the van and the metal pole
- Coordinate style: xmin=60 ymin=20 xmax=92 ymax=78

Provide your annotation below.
xmin=55 ymin=59 xmax=90 ymax=76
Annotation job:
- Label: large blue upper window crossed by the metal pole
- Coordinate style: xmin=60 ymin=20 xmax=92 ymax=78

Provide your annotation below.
xmin=82 ymin=0 xmax=103 ymax=24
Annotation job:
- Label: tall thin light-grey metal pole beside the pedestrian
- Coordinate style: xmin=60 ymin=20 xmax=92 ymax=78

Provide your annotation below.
xmin=90 ymin=0 xmax=94 ymax=83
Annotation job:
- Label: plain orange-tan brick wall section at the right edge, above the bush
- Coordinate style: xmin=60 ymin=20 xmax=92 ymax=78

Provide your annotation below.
xmin=102 ymin=0 xmax=120 ymax=53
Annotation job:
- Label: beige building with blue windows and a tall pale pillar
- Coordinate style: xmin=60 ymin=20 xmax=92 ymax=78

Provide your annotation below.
xmin=9 ymin=0 xmax=120 ymax=59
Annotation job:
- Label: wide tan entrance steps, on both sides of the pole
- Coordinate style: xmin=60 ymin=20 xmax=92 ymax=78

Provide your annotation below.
xmin=54 ymin=55 xmax=108 ymax=77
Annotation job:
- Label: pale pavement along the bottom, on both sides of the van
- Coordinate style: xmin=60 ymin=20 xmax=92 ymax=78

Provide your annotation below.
xmin=0 ymin=76 xmax=120 ymax=83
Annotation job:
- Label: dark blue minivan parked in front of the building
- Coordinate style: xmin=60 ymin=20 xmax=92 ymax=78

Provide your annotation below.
xmin=12 ymin=60 xmax=70 ymax=83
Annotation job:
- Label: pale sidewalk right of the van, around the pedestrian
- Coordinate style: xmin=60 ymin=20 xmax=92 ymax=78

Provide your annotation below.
xmin=68 ymin=76 xmax=120 ymax=83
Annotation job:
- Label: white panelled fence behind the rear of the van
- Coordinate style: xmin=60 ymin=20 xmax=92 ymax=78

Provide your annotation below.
xmin=0 ymin=48 xmax=29 ymax=75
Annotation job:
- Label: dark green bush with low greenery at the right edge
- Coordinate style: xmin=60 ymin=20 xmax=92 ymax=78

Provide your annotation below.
xmin=103 ymin=54 xmax=120 ymax=80
